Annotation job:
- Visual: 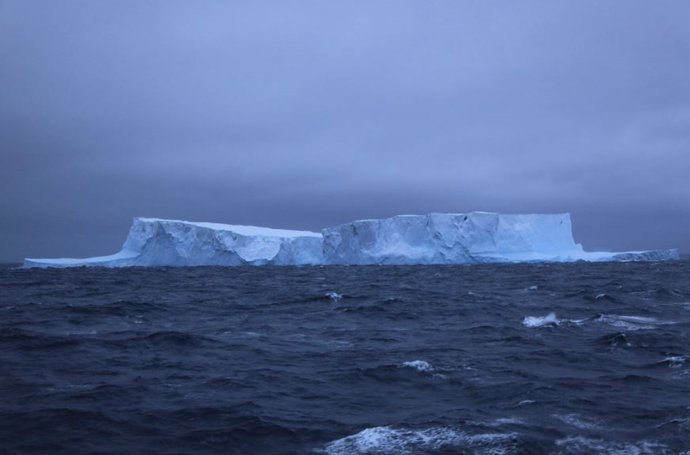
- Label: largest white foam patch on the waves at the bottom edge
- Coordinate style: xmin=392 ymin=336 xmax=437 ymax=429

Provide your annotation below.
xmin=321 ymin=426 xmax=518 ymax=455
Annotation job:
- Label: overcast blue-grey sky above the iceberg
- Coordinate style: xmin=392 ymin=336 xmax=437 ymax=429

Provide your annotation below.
xmin=0 ymin=0 xmax=690 ymax=261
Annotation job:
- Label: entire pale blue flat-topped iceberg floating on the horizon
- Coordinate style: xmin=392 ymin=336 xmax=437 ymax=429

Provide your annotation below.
xmin=24 ymin=212 xmax=679 ymax=267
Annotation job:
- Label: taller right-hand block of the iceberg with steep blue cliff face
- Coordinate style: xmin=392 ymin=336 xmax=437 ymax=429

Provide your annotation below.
xmin=323 ymin=212 xmax=582 ymax=264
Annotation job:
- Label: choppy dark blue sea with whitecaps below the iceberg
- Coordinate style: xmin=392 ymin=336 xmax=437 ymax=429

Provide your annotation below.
xmin=0 ymin=262 xmax=690 ymax=455
